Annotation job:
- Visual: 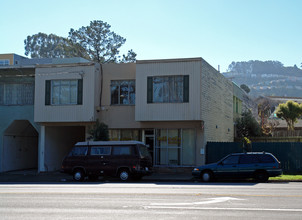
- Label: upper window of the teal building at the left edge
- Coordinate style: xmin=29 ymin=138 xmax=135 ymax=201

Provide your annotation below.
xmin=0 ymin=83 xmax=34 ymax=105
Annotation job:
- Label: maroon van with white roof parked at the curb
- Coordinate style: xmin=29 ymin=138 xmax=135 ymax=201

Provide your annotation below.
xmin=61 ymin=141 xmax=152 ymax=181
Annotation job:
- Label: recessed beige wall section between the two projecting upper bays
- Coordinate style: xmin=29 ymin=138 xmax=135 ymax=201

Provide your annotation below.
xmin=98 ymin=63 xmax=140 ymax=129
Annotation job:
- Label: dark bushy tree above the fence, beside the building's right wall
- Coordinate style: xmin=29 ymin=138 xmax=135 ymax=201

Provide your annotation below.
xmin=236 ymin=110 xmax=261 ymax=138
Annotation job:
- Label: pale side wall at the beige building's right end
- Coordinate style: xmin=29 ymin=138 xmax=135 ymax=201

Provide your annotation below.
xmin=200 ymin=60 xmax=234 ymax=142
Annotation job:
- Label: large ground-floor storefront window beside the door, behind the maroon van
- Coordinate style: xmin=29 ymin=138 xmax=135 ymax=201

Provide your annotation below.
xmin=155 ymin=129 xmax=195 ymax=166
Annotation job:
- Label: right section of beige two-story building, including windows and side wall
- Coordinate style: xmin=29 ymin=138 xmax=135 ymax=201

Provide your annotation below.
xmin=98 ymin=58 xmax=234 ymax=167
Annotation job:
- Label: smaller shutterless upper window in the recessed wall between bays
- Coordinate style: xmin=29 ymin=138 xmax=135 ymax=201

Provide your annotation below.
xmin=111 ymin=80 xmax=135 ymax=105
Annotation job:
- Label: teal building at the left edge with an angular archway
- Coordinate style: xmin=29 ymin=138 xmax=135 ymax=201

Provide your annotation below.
xmin=0 ymin=54 xmax=92 ymax=172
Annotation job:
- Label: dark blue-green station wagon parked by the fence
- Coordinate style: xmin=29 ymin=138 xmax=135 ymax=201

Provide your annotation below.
xmin=192 ymin=152 xmax=282 ymax=182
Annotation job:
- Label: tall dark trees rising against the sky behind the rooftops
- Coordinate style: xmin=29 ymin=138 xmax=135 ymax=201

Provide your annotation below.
xmin=24 ymin=20 xmax=136 ymax=63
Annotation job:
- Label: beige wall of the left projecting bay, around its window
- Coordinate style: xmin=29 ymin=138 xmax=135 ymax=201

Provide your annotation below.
xmin=35 ymin=63 xmax=100 ymax=122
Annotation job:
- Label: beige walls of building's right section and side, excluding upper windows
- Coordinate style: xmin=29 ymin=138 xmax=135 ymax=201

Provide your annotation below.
xmin=97 ymin=58 xmax=234 ymax=166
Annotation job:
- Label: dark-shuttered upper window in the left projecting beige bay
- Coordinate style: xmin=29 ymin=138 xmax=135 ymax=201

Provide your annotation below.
xmin=45 ymin=79 xmax=83 ymax=105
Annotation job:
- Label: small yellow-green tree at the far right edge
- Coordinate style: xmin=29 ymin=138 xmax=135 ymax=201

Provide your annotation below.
xmin=276 ymin=100 xmax=302 ymax=131
